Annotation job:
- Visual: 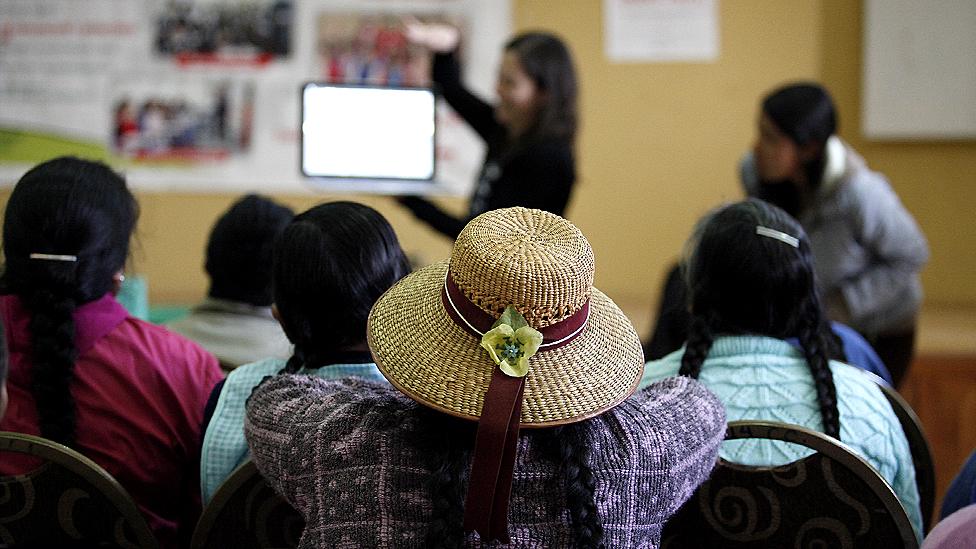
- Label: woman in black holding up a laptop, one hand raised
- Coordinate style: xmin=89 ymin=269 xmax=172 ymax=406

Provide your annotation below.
xmin=400 ymin=20 xmax=578 ymax=239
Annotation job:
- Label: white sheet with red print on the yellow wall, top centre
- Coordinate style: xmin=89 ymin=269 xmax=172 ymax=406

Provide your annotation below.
xmin=603 ymin=0 xmax=719 ymax=63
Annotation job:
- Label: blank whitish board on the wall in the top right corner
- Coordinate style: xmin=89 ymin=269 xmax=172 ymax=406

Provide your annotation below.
xmin=861 ymin=0 xmax=976 ymax=140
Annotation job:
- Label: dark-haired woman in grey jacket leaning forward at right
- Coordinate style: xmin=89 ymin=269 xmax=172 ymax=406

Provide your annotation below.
xmin=740 ymin=82 xmax=929 ymax=387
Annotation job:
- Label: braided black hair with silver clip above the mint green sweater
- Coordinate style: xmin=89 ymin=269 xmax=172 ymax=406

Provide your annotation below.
xmin=680 ymin=199 xmax=840 ymax=438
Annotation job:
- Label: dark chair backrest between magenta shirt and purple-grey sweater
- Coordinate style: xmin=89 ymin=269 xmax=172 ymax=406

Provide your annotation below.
xmin=190 ymin=460 xmax=305 ymax=549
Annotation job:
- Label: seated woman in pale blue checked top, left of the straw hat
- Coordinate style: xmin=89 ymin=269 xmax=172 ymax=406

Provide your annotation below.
xmin=200 ymin=202 xmax=410 ymax=502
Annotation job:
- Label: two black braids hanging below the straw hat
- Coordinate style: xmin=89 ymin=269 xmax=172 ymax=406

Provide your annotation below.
xmin=418 ymin=407 xmax=604 ymax=548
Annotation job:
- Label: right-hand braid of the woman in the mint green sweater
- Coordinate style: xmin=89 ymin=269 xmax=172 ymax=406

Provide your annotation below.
xmin=798 ymin=294 xmax=840 ymax=440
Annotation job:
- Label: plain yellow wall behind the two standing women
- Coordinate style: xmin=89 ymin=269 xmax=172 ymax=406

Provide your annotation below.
xmin=0 ymin=0 xmax=976 ymax=326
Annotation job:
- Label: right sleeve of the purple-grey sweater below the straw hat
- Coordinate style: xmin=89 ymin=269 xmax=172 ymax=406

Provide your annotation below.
xmin=621 ymin=377 xmax=725 ymax=517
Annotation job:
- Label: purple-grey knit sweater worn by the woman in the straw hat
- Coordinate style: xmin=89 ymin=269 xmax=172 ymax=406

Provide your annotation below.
xmin=244 ymin=375 xmax=725 ymax=547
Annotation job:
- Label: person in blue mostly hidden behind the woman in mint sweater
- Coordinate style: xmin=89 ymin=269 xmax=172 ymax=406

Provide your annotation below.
xmin=644 ymin=264 xmax=894 ymax=387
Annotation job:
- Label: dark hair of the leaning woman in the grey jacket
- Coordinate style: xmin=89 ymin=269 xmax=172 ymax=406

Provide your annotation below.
xmin=762 ymin=82 xmax=837 ymax=190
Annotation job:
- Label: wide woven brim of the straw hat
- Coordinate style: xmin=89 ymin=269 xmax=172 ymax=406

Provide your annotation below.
xmin=367 ymin=261 xmax=644 ymax=427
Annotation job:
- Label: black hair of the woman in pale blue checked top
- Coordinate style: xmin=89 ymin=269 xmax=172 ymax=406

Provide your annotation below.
xmin=272 ymin=202 xmax=410 ymax=372
